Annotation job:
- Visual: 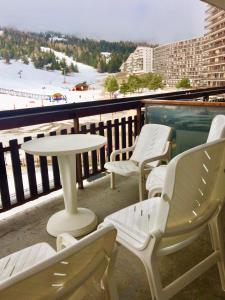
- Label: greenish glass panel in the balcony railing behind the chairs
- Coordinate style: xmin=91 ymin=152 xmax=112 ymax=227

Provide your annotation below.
xmin=145 ymin=105 xmax=225 ymax=156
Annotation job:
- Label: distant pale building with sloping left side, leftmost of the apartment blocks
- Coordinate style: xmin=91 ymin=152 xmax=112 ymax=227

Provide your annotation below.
xmin=120 ymin=46 xmax=153 ymax=74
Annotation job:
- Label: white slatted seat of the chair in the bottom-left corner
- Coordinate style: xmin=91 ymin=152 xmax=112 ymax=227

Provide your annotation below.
xmin=0 ymin=243 xmax=56 ymax=281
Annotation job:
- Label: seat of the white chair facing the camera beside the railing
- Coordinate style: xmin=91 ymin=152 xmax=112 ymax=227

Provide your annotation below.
xmin=104 ymin=160 xmax=138 ymax=176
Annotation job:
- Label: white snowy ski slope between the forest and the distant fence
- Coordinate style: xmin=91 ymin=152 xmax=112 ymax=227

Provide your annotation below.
xmin=0 ymin=48 xmax=105 ymax=92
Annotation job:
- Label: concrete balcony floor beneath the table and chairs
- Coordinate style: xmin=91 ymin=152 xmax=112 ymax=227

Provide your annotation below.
xmin=0 ymin=176 xmax=225 ymax=300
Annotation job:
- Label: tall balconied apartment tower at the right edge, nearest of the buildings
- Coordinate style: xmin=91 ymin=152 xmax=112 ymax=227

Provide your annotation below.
xmin=203 ymin=6 xmax=225 ymax=87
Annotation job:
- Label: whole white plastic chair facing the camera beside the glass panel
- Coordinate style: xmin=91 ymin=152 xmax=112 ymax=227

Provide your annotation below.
xmin=104 ymin=124 xmax=171 ymax=201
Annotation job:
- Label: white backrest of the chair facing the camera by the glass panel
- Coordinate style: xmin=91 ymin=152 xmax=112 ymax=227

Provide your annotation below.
xmin=130 ymin=124 xmax=172 ymax=167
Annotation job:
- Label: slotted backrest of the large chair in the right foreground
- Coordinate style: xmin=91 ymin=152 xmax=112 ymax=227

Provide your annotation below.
xmin=158 ymin=139 xmax=225 ymax=234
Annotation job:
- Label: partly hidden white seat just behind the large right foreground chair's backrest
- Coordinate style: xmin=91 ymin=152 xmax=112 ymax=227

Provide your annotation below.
xmin=146 ymin=165 xmax=167 ymax=193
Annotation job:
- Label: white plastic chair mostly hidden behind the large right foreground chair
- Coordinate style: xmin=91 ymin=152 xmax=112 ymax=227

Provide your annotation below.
xmin=146 ymin=115 xmax=225 ymax=198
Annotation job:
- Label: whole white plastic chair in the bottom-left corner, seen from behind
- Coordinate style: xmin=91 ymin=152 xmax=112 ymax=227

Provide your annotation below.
xmin=0 ymin=226 xmax=119 ymax=300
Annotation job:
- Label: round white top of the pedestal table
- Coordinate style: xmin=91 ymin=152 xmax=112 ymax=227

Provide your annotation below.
xmin=21 ymin=134 xmax=106 ymax=156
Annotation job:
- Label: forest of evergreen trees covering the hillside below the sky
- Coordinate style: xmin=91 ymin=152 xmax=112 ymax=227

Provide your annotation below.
xmin=0 ymin=28 xmax=156 ymax=73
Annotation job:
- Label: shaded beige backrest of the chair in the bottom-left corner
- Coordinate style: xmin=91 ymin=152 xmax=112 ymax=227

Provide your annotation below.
xmin=0 ymin=226 xmax=116 ymax=300
